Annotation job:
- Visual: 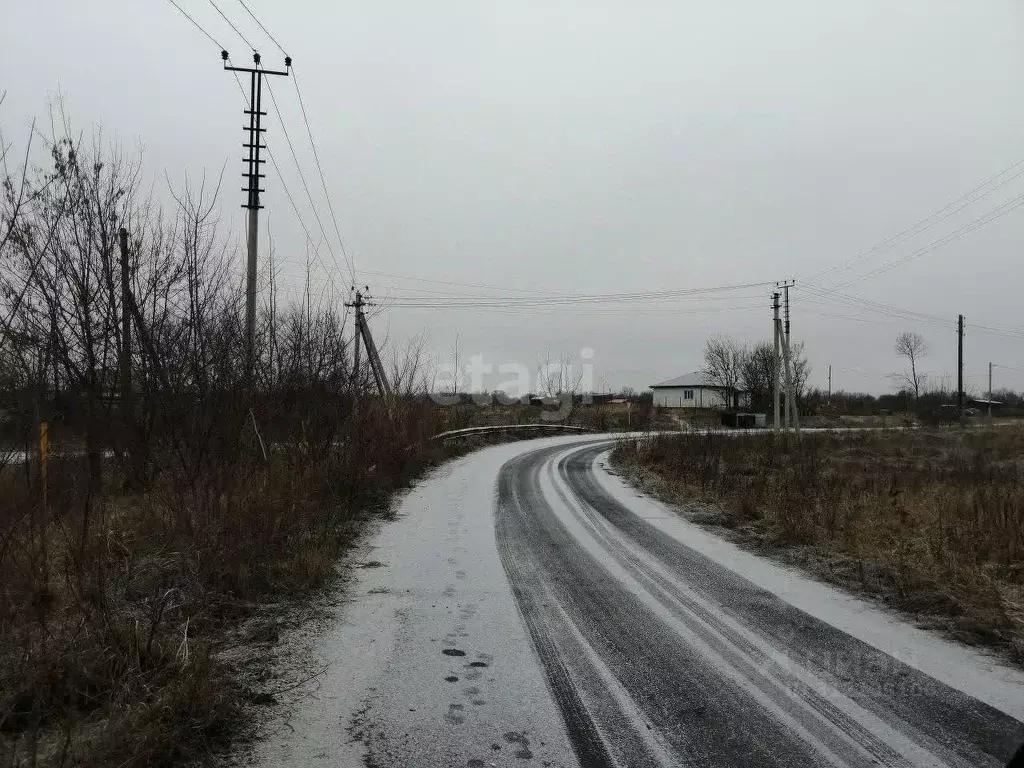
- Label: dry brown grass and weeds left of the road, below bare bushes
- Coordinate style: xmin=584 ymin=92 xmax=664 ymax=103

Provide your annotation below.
xmin=0 ymin=406 xmax=485 ymax=766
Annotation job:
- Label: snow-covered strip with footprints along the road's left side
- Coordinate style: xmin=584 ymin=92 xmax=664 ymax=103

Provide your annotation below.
xmin=245 ymin=435 xmax=594 ymax=768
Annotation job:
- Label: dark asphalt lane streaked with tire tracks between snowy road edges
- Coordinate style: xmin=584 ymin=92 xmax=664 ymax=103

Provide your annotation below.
xmin=496 ymin=443 xmax=1024 ymax=766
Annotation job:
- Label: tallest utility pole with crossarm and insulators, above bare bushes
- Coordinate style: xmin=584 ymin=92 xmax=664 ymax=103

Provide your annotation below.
xmin=220 ymin=50 xmax=292 ymax=385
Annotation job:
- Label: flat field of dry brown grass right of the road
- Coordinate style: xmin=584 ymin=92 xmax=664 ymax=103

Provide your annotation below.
xmin=614 ymin=427 xmax=1024 ymax=662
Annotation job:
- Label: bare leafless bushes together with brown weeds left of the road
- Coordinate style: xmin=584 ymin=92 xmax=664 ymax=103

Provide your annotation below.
xmin=0 ymin=116 xmax=544 ymax=766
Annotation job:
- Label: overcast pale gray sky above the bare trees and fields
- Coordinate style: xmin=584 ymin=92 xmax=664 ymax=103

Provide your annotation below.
xmin=0 ymin=0 xmax=1024 ymax=391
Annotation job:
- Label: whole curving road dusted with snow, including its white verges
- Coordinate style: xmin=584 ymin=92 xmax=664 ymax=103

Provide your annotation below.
xmin=253 ymin=437 xmax=1024 ymax=768
